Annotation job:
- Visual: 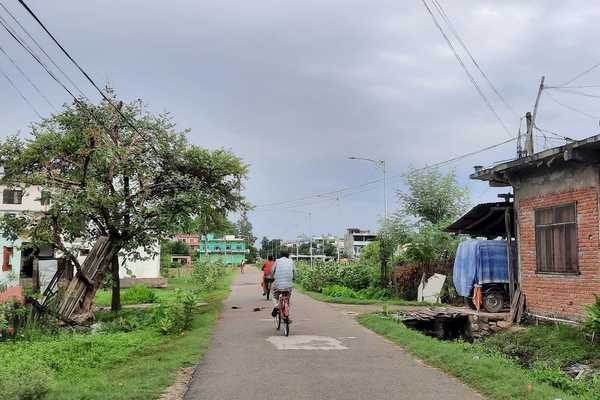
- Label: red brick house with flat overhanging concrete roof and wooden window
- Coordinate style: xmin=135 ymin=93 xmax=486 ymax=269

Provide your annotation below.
xmin=470 ymin=135 xmax=600 ymax=319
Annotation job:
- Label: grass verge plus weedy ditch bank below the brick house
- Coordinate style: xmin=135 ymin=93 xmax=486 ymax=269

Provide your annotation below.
xmin=358 ymin=312 xmax=600 ymax=400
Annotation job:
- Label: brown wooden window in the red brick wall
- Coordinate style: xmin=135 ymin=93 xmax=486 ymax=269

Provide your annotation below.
xmin=535 ymin=203 xmax=579 ymax=274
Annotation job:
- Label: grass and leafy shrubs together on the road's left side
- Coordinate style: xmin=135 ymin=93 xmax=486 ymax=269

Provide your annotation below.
xmin=0 ymin=268 xmax=236 ymax=400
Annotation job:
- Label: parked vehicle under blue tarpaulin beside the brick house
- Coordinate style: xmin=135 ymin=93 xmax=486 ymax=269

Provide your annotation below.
xmin=452 ymin=240 xmax=517 ymax=313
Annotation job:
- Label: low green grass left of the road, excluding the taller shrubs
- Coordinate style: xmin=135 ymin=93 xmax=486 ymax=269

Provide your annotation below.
xmin=0 ymin=269 xmax=237 ymax=400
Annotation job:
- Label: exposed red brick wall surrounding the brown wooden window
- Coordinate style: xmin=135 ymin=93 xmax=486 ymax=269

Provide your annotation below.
xmin=519 ymin=187 xmax=600 ymax=319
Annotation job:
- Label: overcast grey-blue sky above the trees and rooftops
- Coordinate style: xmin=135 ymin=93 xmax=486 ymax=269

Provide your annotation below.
xmin=0 ymin=0 xmax=600 ymax=245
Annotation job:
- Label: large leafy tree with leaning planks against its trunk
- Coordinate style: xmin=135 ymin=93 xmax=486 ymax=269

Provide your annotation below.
xmin=0 ymin=93 xmax=249 ymax=318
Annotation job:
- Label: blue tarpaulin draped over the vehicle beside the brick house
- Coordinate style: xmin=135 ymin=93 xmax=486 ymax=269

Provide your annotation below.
xmin=452 ymin=240 xmax=517 ymax=296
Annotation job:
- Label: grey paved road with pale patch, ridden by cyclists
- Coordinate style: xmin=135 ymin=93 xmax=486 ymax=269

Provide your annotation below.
xmin=184 ymin=266 xmax=482 ymax=400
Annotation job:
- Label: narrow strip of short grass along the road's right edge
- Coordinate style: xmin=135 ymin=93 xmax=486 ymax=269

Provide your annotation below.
xmin=357 ymin=313 xmax=578 ymax=400
